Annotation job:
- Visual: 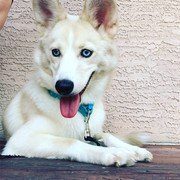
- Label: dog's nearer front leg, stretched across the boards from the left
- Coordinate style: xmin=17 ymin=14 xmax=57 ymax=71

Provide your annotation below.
xmin=2 ymin=117 xmax=135 ymax=166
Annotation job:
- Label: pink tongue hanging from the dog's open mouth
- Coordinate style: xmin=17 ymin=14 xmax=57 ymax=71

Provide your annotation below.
xmin=60 ymin=94 xmax=81 ymax=118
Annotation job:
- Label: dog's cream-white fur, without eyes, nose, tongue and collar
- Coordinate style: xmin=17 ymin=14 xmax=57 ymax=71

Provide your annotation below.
xmin=2 ymin=0 xmax=152 ymax=166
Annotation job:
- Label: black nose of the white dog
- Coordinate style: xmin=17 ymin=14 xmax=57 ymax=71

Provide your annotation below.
xmin=55 ymin=79 xmax=74 ymax=96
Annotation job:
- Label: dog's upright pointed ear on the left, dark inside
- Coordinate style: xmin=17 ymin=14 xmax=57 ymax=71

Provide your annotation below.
xmin=33 ymin=0 xmax=66 ymax=27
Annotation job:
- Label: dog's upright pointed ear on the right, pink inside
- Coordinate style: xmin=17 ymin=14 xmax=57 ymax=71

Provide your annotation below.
xmin=82 ymin=0 xmax=117 ymax=36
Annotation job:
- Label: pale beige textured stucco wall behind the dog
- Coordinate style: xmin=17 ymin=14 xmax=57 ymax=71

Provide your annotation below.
xmin=0 ymin=0 xmax=180 ymax=143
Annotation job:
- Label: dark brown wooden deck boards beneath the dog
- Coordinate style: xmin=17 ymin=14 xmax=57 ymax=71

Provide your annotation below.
xmin=0 ymin=142 xmax=180 ymax=180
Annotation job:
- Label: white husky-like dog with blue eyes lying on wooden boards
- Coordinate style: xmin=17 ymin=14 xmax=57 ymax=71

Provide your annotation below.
xmin=2 ymin=0 xmax=153 ymax=166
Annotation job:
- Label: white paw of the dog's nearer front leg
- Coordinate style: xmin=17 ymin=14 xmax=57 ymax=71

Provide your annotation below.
xmin=101 ymin=147 xmax=136 ymax=167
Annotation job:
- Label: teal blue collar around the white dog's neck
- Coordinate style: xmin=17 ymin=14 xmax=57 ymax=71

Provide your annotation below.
xmin=47 ymin=89 xmax=94 ymax=118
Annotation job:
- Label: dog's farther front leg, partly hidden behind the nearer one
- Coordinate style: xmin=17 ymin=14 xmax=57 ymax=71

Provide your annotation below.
xmin=94 ymin=133 xmax=153 ymax=162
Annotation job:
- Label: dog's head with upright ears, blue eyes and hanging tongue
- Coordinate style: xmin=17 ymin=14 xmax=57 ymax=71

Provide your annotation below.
xmin=33 ymin=0 xmax=117 ymax=118
